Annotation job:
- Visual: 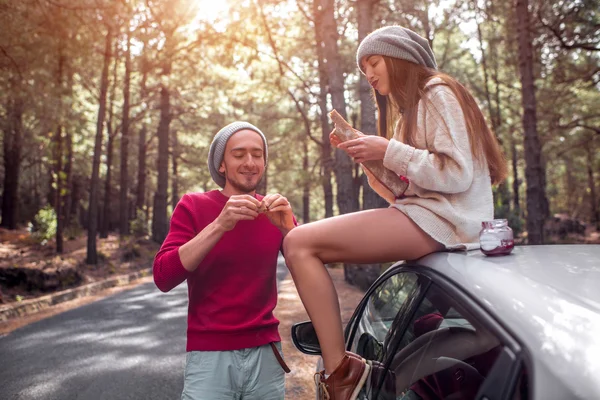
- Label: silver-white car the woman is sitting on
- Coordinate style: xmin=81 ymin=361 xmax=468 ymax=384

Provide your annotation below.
xmin=292 ymin=245 xmax=600 ymax=400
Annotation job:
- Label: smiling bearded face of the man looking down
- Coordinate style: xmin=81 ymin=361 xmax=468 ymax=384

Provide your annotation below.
xmin=219 ymin=129 xmax=265 ymax=195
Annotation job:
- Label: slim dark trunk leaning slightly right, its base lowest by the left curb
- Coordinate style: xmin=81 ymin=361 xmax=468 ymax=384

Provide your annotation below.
xmin=85 ymin=30 xmax=112 ymax=264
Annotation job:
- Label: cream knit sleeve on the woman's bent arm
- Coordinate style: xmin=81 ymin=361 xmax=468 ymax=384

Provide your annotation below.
xmin=383 ymin=86 xmax=473 ymax=193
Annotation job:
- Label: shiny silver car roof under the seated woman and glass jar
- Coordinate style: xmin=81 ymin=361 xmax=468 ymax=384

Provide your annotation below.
xmin=416 ymin=244 xmax=600 ymax=399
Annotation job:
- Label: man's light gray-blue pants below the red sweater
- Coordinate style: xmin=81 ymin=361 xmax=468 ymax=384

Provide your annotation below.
xmin=181 ymin=343 xmax=285 ymax=400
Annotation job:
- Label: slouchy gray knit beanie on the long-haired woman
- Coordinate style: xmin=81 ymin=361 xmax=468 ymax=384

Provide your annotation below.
xmin=356 ymin=25 xmax=437 ymax=73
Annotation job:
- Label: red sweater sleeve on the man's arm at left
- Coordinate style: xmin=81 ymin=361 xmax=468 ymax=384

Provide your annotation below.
xmin=152 ymin=194 xmax=196 ymax=292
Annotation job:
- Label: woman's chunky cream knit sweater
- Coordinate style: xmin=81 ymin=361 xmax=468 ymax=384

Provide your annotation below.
xmin=365 ymin=78 xmax=494 ymax=249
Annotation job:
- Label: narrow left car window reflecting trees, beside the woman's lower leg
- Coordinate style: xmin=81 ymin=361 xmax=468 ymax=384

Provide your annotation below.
xmin=350 ymin=272 xmax=418 ymax=361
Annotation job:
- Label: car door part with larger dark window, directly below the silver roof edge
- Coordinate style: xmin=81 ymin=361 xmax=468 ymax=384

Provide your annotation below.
xmin=376 ymin=267 xmax=528 ymax=400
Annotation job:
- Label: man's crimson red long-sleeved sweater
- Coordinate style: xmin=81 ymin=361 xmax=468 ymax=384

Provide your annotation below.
xmin=153 ymin=190 xmax=283 ymax=351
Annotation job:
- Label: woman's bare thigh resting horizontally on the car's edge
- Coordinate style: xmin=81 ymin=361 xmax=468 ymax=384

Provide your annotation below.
xmin=284 ymin=208 xmax=443 ymax=264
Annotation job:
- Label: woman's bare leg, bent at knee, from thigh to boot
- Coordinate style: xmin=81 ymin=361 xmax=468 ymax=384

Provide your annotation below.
xmin=283 ymin=208 xmax=443 ymax=374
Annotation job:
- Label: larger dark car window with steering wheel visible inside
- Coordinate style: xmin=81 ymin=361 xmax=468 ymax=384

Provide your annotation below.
xmin=378 ymin=284 xmax=502 ymax=400
